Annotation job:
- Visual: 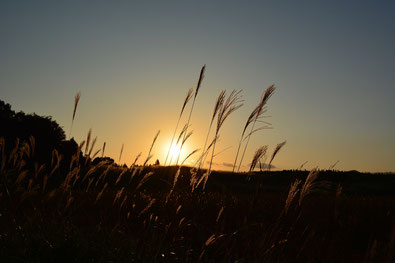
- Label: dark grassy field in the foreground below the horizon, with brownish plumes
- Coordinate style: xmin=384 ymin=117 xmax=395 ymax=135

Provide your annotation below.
xmin=0 ymin=139 xmax=395 ymax=262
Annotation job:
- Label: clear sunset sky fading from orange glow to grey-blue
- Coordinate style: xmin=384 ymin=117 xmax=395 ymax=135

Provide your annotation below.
xmin=0 ymin=0 xmax=395 ymax=172
